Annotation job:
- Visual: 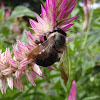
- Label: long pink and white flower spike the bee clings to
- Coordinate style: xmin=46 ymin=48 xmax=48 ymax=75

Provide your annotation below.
xmin=0 ymin=0 xmax=77 ymax=93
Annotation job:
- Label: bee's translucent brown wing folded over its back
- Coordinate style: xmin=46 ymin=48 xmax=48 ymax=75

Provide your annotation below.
xmin=27 ymin=37 xmax=54 ymax=60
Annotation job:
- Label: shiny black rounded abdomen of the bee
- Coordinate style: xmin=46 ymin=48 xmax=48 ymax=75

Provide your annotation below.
xmin=35 ymin=52 xmax=58 ymax=67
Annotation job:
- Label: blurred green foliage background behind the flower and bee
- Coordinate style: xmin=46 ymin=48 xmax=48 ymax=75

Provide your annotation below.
xmin=0 ymin=0 xmax=100 ymax=100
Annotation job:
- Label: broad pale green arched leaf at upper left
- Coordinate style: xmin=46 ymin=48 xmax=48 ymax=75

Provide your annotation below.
xmin=10 ymin=6 xmax=35 ymax=18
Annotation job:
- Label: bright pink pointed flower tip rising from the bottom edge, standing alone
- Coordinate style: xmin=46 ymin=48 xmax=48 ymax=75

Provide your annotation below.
xmin=68 ymin=80 xmax=77 ymax=100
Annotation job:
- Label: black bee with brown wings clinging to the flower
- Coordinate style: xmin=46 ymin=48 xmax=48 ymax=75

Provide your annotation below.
xmin=27 ymin=27 xmax=66 ymax=67
